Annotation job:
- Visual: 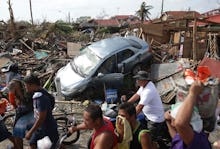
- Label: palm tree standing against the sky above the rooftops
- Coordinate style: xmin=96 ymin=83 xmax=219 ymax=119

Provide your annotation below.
xmin=136 ymin=2 xmax=153 ymax=23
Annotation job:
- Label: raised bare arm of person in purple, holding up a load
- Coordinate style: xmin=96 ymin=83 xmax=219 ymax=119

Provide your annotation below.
xmin=175 ymin=81 xmax=203 ymax=145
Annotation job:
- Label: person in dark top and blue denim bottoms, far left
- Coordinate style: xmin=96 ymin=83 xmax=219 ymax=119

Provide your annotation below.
xmin=8 ymin=79 xmax=34 ymax=149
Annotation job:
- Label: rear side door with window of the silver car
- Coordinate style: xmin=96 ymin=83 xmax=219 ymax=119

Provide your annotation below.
xmin=117 ymin=49 xmax=137 ymax=73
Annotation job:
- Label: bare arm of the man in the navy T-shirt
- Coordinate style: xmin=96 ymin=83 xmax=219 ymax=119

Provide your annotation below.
xmin=25 ymin=111 xmax=47 ymax=140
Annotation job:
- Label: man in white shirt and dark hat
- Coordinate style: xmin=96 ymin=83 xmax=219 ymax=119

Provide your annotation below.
xmin=128 ymin=71 xmax=165 ymax=144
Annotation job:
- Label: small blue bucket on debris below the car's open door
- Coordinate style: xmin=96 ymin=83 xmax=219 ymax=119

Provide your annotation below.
xmin=105 ymin=89 xmax=118 ymax=103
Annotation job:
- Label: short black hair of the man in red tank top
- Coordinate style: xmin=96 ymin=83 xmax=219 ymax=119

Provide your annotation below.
xmin=85 ymin=104 xmax=103 ymax=120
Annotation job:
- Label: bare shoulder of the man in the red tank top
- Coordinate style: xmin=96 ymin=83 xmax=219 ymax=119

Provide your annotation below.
xmin=94 ymin=132 xmax=114 ymax=149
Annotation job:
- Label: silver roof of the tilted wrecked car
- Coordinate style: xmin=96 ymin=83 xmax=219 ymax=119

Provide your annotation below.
xmin=88 ymin=37 xmax=147 ymax=58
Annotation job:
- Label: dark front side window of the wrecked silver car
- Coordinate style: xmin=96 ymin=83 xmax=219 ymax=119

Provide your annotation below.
xmin=98 ymin=55 xmax=117 ymax=74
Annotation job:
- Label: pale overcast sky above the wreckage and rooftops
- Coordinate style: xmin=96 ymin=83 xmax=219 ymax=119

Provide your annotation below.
xmin=0 ymin=0 xmax=220 ymax=22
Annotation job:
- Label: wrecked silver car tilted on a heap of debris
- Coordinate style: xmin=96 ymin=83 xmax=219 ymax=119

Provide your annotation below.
xmin=55 ymin=36 xmax=152 ymax=98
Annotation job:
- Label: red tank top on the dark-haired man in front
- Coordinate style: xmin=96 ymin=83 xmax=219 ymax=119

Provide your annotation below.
xmin=90 ymin=118 xmax=118 ymax=149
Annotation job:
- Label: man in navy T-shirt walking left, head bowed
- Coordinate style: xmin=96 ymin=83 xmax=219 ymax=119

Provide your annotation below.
xmin=24 ymin=74 xmax=59 ymax=149
